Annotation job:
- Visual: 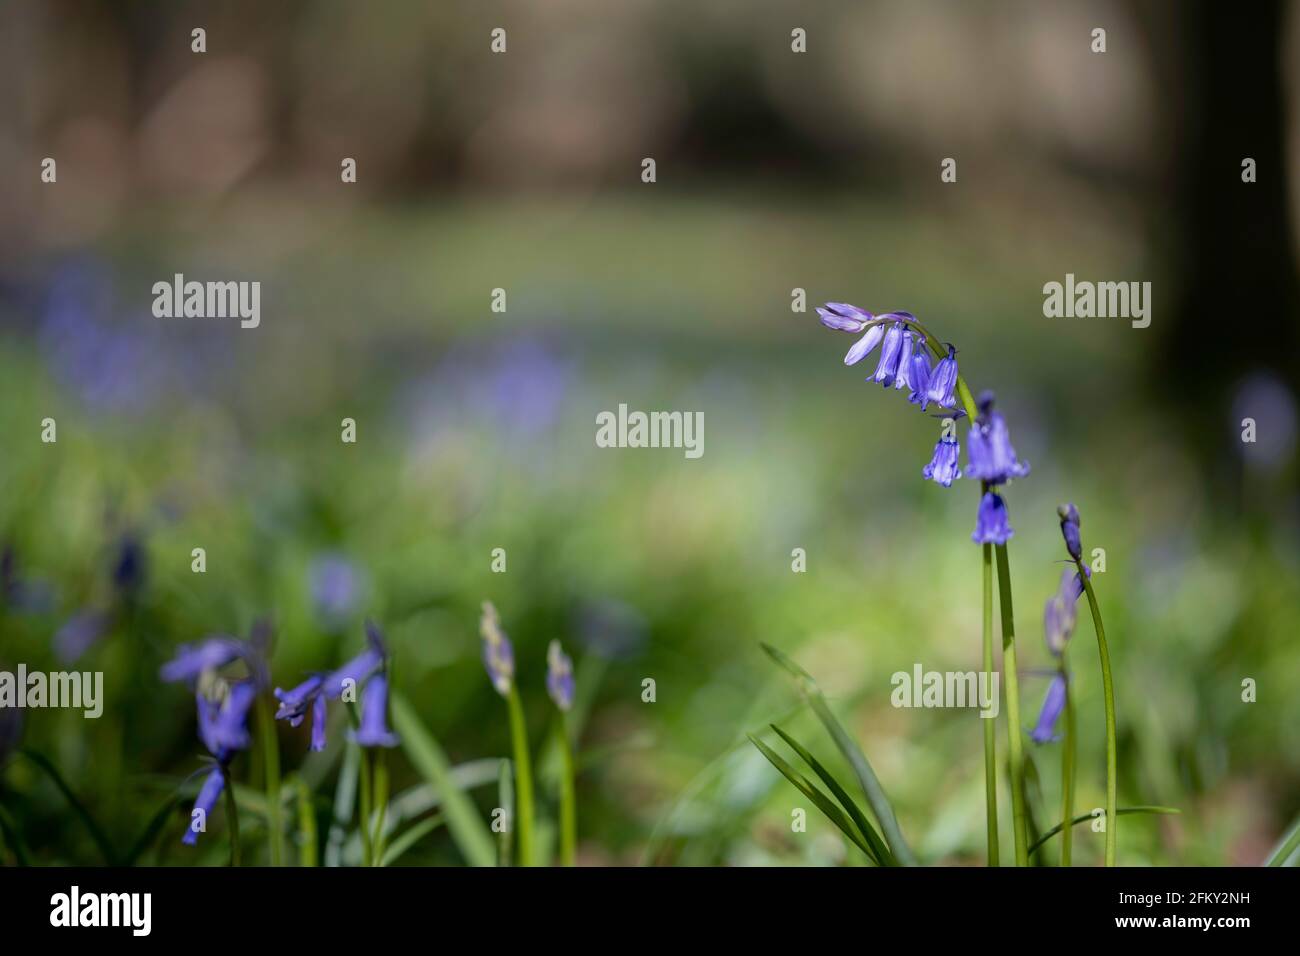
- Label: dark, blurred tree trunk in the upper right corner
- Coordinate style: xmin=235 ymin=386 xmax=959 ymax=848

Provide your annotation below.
xmin=1141 ymin=0 xmax=1300 ymax=411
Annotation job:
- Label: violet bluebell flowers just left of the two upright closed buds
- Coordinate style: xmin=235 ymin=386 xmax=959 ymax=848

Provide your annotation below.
xmin=276 ymin=620 xmax=399 ymax=750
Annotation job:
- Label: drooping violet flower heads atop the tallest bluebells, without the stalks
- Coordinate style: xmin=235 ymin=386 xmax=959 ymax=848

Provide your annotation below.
xmin=818 ymin=302 xmax=1030 ymax=545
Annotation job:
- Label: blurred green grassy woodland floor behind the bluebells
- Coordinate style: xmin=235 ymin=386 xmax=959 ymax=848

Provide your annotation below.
xmin=0 ymin=196 xmax=1300 ymax=864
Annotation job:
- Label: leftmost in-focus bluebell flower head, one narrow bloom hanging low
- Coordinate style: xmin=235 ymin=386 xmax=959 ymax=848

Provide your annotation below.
xmin=161 ymin=623 xmax=270 ymax=847
